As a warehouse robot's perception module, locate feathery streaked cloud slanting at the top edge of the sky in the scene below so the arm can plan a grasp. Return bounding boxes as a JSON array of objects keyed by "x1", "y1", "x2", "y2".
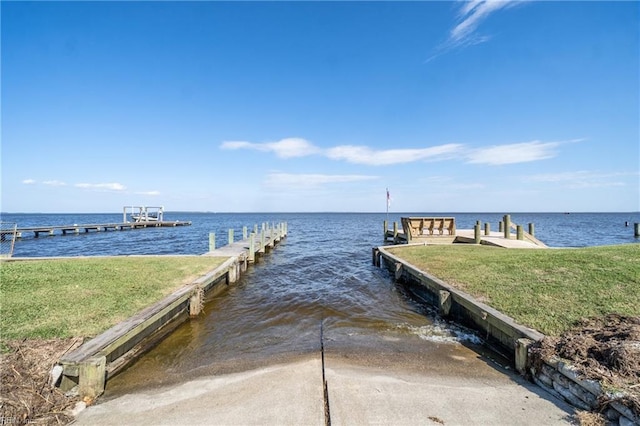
[{"x1": 427, "y1": 0, "x2": 527, "y2": 62}]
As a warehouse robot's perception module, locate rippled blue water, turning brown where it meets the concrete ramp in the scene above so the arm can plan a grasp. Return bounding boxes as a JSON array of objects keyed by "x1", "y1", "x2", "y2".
[{"x1": 2, "y1": 212, "x2": 640, "y2": 396}]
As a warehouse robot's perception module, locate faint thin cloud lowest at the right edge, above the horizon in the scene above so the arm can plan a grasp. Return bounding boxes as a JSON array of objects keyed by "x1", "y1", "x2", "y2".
[{"x1": 524, "y1": 170, "x2": 640, "y2": 189}]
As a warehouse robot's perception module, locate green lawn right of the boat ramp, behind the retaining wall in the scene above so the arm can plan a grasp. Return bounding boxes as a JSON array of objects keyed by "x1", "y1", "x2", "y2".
[{"x1": 387, "y1": 244, "x2": 640, "y2": 335}]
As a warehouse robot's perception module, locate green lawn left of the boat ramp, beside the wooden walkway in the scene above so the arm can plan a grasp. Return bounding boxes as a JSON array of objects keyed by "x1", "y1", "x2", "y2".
[{"x1": 0, "y1": 256, "x2": 226, "y2": 339}]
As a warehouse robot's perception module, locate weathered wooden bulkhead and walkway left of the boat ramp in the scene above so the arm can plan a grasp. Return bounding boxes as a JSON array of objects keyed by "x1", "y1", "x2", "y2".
[{"x1": 57, "y1": 223, "x2": 287, "y2": 398}]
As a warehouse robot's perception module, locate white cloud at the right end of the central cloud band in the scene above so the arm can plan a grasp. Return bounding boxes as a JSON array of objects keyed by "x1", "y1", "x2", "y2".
[{"x1": 467, "y1": 141, "x2": 561, "y2": 166}]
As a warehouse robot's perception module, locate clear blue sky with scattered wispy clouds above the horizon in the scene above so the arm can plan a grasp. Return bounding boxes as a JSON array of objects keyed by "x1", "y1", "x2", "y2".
[{"x1": 0, "y1": 1, "x2": 640, "y2": 213}]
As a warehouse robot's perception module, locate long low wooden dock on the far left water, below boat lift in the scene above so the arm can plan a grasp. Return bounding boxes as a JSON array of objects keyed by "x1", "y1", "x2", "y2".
[{"x1": 0, "y1": 221, "x2": 191, "y2": 241}]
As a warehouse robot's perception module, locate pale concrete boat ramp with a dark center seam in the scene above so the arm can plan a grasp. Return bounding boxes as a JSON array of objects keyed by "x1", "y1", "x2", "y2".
[{"x1": 75, "y1": 342, "x2": 573, "y2": 426}]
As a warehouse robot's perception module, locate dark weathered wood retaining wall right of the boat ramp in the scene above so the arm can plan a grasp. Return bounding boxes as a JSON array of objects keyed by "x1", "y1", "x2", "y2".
[{"x1": 373, "y1": 244, "x2": 640, "y2": 426}]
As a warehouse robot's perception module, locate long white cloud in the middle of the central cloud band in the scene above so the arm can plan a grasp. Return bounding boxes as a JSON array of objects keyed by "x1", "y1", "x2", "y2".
[{"x1": 326, "y1": 144, "x2": 462, "y2": 166}]
